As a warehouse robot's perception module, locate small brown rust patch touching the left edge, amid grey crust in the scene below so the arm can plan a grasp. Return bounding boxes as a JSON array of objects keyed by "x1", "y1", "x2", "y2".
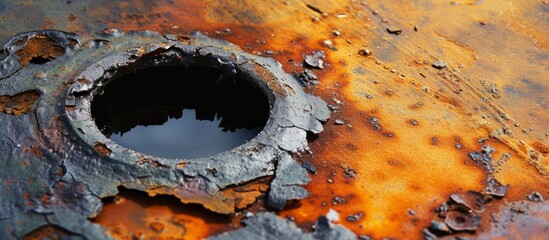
[{"x1": 0, "y1": 90, "x2": 40, "y2": 116}]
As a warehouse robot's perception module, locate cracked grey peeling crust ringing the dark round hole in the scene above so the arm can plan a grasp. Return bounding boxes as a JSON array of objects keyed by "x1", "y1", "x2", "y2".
[{"x1": 0, "y1": 29, "x2": 329, "y2": 238}]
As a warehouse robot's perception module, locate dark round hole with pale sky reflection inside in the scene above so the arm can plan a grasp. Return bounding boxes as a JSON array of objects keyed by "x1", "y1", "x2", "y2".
[{"x1": 91, "y1": 66, "x2": 270, "y2": 158}]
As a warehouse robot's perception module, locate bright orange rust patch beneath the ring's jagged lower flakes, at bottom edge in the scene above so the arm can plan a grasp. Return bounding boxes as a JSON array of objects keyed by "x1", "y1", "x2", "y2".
[{"x1": 92, "y1": 190, "x2": 235, "y2": 239}]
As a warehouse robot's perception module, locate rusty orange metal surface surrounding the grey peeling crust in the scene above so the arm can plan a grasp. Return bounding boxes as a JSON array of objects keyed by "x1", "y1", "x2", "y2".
[{"x1": 0, "y1": 0, "x2": 549, "y2": 239}]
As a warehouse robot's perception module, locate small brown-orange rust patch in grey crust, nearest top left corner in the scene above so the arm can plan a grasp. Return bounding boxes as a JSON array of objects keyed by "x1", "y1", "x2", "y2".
[{"x1": 15, "y1": 36, "x2": 65, "y2": 65}]
